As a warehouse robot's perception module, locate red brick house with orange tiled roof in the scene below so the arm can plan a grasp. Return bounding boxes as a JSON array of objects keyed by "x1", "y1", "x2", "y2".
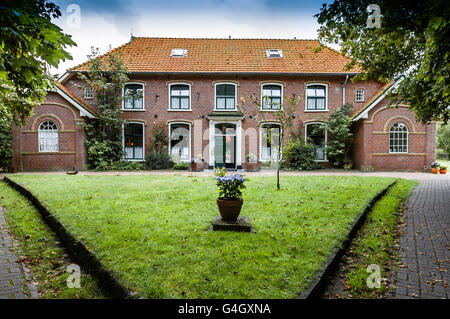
[{"x1": 9, "y1": 37, "x2": 435, "y2": 171}]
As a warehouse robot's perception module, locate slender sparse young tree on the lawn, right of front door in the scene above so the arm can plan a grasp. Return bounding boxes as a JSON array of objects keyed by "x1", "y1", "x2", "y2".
[{"x1": 238, "y1": 95, "x2": 301, "y2": 190}]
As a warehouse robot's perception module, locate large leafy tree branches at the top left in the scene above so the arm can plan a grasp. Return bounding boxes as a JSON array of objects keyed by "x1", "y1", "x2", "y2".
[{"x1": 0, "y1": 0, "x2": 76, "y2": 124}]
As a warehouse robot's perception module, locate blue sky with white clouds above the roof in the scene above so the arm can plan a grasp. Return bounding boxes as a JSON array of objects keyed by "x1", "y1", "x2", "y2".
[{"x1": 52, "y1": 0, "x2": 329, "y2": 75}]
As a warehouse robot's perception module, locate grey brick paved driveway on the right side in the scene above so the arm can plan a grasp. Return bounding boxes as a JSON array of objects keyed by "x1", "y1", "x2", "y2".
[{"x1": 395, "y1": 178, "x2": 450, "y2": 299}]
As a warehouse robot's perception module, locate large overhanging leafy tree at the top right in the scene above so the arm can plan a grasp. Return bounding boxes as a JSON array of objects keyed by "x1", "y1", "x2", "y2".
[{"x1": 316, "y1": 0, "x2": 450, "y2": 122}]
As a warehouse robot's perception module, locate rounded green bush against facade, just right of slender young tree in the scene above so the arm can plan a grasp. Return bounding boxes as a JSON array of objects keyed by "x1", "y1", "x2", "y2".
[{"x1": 281, "y1": 137, "x2": 321, "y2": 171}]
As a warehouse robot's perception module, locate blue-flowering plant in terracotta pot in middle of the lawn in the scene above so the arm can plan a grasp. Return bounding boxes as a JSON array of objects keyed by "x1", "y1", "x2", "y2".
[{"x1": 215, "y1": 168, "x2": 245, "y2": 222}]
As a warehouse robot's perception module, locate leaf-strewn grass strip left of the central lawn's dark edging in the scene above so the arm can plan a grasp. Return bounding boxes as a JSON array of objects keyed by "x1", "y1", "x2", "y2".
[{"x1": 0, "y1": 181, "x2": 102, "y2": 298}]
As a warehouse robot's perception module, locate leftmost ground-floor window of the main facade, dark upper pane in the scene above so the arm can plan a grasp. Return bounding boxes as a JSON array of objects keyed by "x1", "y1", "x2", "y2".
[{"x1": 123, "y1": 122, "x2": 145, "y2": 161}]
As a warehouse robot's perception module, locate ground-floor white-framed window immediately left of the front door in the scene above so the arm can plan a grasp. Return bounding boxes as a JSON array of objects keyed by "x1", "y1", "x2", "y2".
[{"x1": 169, "y1": 122, "x2": 191, "y2": 163}]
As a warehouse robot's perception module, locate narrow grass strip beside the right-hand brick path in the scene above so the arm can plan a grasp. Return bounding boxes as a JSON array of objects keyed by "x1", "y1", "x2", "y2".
[{"x1": 336, "y1": 179, "x2": 418, "y2": 298}]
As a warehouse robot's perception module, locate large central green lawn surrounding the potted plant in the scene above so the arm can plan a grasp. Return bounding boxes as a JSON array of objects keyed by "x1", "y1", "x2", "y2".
[{"x1": 6, "y1": 175, "x2": 393, "y2": 298}]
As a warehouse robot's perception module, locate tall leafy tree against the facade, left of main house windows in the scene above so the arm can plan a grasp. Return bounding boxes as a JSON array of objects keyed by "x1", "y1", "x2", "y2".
[{"x1": 78, "y1": 48, "x2": 130, "y2": 169}]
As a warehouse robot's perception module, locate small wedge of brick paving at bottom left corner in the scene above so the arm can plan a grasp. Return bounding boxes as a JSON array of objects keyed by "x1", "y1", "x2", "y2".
[{"x1": 0, "y1": 206, "x2": 36, "y2": 299}]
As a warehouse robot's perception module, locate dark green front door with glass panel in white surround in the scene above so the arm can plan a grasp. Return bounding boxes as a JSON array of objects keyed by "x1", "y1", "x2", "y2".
[{"x1": 214, "y1": 123, "x2": 236, "y2": 169}]
